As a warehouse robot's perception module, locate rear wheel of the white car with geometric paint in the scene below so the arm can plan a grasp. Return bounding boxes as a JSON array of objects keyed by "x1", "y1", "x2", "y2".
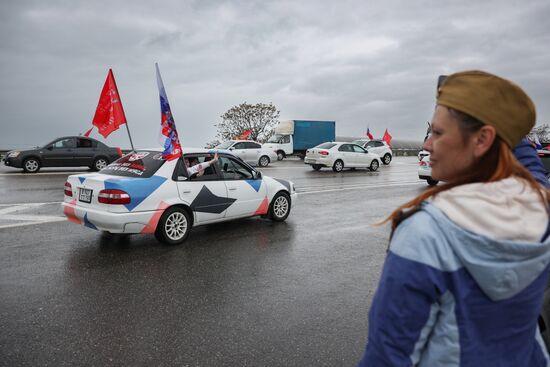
[{"x1": 155, "y1": 207, "x2": 191, "y2": 245}]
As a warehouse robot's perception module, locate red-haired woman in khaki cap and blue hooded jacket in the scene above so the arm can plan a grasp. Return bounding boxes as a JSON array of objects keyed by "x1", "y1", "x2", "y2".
[{"x1": 360, "y1": 71, "x2": 550, "y2": 367}]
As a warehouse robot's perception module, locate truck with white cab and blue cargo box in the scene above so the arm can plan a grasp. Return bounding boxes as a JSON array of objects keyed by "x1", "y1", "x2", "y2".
[{"x1": 262, "y1": 120, "x2": 336, "y2": 160}]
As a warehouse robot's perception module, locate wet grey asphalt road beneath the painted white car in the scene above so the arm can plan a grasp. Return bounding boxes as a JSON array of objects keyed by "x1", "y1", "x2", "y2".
[{"x1": 0, "y1": 157, "x2": 426, "y2": 366}]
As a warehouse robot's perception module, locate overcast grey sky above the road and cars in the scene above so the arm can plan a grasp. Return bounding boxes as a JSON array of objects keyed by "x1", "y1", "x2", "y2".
[{"x1": 0, "y1": 0, "x2": 550, "y2": 149}]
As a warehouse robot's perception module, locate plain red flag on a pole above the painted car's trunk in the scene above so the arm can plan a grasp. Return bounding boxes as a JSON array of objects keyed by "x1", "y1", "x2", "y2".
[{"x1": 92, "y1": 69, "x2": 126, "y2": 138}]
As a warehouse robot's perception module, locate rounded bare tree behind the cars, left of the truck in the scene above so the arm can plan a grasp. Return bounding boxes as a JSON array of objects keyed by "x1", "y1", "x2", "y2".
[{"x1": 214, "y1": 102, "x2": 280, "y2": 141}]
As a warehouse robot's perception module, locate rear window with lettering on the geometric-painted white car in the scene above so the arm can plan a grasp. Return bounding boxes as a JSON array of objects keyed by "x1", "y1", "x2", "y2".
[{"x1": 99, "y1": 151, "x2": 166, "y2": 178}]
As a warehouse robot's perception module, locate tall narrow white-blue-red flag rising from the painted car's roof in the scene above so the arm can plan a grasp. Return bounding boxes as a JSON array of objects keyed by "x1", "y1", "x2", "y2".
[{"x1": 155, "y1": 63, "x2": 181, "y2": 161}]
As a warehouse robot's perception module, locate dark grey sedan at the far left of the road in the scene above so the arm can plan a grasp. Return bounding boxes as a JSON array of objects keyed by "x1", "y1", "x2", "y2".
[{"x1": 4, "y1": 136, "x2": 122, "y2": 173}]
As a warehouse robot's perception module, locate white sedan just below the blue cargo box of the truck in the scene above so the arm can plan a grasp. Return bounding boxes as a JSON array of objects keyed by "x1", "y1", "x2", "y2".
[{"x1": 304, "y1": 142, "x2": 381, "y2": 172}]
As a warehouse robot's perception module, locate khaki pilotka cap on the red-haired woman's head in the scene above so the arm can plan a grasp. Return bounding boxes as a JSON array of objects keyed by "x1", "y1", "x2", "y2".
[{"x1": 437, "y1": 70, "x2": 536, "y2": 148}]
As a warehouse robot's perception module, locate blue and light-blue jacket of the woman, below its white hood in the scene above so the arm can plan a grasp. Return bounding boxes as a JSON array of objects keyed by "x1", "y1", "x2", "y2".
[{"x1": 359, "y1": 203, "x2": 550, "y2": 367}]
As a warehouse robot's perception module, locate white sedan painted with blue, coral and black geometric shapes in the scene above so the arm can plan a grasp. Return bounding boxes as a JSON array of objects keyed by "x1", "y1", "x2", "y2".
[{"x1": 62, "y1": 149, "x2": 297, "y2": 244}]
